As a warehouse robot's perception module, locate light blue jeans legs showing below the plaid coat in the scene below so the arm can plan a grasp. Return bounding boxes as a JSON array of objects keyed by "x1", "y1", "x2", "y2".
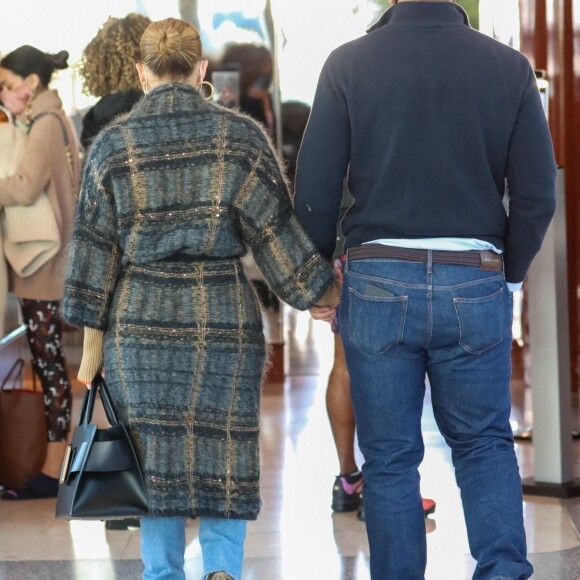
[{"x1": 141, "y1": 516, "x2": 247, "y2": 580}]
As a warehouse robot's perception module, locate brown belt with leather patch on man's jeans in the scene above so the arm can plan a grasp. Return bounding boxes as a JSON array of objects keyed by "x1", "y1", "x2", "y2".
[{"x1": 347, "y1": 244, "x2": 503, "y2": 272}]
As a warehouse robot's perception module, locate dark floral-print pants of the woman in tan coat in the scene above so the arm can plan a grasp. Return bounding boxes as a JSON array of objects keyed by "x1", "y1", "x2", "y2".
[{"x1": 20, "y1": 299, "x2": 72, "y2": 442}]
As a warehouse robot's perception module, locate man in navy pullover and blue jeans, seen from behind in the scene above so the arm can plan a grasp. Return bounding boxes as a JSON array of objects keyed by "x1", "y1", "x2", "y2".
[{"x1": 295, "y1": 0, "x2": 556, "y2": 580}]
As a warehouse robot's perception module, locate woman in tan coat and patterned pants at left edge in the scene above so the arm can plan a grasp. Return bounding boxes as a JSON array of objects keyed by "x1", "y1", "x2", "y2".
[{"x1": 0, "y1": 45, "x2": 80, "y2": 500}]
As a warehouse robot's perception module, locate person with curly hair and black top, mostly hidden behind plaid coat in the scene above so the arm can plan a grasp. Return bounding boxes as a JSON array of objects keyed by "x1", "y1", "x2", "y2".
[{"x1": 79, "y1": 12, "x2": 151, "y2": 149}]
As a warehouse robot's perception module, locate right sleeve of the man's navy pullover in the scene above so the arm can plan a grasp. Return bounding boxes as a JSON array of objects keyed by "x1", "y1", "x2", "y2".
[{"x1": 505, "y1": 67, "x2": 556, "y2": 282}]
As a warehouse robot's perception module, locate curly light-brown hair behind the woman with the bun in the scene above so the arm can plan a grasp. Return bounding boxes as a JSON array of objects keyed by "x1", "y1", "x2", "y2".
[{"x1": 79, "y1": 12, "x2": 151, "y2": 97}]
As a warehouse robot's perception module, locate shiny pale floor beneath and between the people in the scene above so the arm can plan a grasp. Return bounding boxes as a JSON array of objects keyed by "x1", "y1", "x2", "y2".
[{"x1": 0, "y1": 312, "x2": 580, "y2": 580}]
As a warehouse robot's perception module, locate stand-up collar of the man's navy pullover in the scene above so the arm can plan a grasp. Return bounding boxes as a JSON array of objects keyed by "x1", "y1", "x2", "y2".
[{"x1": 367, "y1": 2, "x2": 469, "y2": 32}]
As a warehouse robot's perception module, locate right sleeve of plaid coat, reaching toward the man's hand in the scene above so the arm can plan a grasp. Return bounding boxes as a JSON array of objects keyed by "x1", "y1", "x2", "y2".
[{"x1": 236, "y1": 133, "x2": 338, "y2": 310}]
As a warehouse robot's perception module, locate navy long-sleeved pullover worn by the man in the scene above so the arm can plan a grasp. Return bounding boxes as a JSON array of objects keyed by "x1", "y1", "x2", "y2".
[{"x1": 295, "y1": 2, "x2": 556, "y2": 282}]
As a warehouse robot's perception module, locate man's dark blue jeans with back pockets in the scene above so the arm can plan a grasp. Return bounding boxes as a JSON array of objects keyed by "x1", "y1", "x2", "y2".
[{"x1": 340, "y1": 259, "x2": 533, "y2": 580}]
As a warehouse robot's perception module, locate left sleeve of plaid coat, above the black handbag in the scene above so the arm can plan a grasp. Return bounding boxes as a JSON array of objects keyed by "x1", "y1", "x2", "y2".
[{"x1": 62, "y1": 146, "x2": 121, "y2": 330}]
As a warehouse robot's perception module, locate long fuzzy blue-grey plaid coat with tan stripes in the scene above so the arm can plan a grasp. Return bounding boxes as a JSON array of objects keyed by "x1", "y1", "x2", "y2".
[{"x1": 63, "y1": 84, "x2": 333, "y2": 519}]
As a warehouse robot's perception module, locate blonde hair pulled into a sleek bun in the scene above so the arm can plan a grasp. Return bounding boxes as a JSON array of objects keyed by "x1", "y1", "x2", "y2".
[{"x1": 141, "y1": 18, "x2": 202, "y2": 79}]
